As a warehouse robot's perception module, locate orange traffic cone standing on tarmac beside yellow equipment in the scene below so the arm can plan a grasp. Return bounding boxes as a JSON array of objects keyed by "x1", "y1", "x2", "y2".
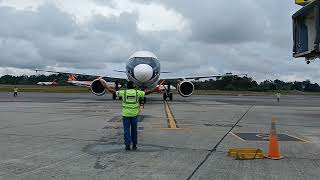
[{"x1": 268, "y1": 118, "x2": 283, "y2": 160}]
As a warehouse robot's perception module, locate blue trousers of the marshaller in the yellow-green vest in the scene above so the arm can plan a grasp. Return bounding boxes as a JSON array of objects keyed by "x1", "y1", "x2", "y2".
[{"x1": 123, "y1": 116, "x2": 138, "y2": 145}]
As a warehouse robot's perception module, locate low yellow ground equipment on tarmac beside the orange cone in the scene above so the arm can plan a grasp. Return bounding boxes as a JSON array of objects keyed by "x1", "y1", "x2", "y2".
[{"x1": 228, "y1": 148, "x2": 264, "y2": 160}]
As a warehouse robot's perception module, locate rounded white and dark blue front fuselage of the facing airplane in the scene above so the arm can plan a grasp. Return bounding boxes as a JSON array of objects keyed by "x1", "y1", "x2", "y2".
[{"x1": 126, "y1": 51, "x2": 160, "y2": 89}]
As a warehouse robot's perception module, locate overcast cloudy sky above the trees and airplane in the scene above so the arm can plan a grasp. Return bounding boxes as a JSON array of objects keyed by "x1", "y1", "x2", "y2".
[{"x1": 0, "y1": 0, "x2": 320, "y2": 82}]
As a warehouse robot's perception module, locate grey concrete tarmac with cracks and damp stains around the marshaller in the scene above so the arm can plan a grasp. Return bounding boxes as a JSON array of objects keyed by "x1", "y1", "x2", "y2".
[{"x1": 0, "y1": 93, "x2": 320, "y2": 180}]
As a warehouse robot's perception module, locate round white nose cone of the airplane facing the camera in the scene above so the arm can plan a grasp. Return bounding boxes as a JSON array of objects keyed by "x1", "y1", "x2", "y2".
[{"x1": 133, "y1": 64, "x2": 153, "y2": 82}]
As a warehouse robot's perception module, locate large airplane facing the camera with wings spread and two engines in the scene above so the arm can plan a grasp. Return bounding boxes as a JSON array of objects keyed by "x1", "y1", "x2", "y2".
[{"x1": 36, "y1": 51, "x2": 242, "y2": 100}]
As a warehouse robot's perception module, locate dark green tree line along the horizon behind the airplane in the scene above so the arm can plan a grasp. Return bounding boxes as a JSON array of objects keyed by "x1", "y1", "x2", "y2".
[{"x1": 0, "y1": 74, "x2": 320, "y2": 92}]
